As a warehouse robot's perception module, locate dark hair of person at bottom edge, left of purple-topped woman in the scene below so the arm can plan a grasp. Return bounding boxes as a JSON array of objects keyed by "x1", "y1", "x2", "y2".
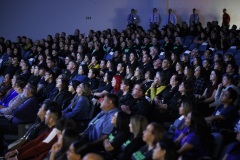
[{"x1": 158, "y1": 139, "x2": 178, "y2": 160}]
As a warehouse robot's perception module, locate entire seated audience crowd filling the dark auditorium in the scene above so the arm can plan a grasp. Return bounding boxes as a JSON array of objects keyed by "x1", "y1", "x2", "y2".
[{"x1": 0, "y1": 10, "x2": 240, "y2": 160}]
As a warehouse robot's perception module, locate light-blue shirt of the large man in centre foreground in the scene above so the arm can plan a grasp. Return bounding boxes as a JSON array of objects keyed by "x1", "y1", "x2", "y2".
[{"x1": 83, "y1": 108, "x2": 119, "y2": 142}]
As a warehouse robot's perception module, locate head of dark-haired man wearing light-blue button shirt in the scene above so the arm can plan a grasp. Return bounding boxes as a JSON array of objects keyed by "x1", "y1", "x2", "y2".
[{"x1": 100, "y1": 94, "x2": 118, "y2": 112}]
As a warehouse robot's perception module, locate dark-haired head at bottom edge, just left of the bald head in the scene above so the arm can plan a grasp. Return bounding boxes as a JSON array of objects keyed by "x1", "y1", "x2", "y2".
[{"x1": 67, "y1": 141, "x2": 90, "y2": 160}]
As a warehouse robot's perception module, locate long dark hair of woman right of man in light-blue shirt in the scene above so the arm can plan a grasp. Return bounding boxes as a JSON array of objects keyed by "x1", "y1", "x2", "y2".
[{"x1": 116, "y1": 111, "x2": 130, "y2": 131}]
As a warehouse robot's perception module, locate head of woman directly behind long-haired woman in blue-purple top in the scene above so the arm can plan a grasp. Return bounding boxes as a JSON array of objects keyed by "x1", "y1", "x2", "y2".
[{"x1": 179, "y1": 98, "x2": 194, "y2": 117}]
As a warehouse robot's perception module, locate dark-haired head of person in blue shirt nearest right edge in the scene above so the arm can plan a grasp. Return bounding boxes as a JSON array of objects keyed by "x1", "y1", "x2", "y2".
[{"x1": 221, "y1": 87, "x2": 237, "y2": 104}]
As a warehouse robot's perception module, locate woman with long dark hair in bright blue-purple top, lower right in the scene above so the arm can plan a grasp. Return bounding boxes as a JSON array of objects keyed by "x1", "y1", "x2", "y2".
[{"x1": 178, "y1": 111, "x2": 212, "y2": 159}]
